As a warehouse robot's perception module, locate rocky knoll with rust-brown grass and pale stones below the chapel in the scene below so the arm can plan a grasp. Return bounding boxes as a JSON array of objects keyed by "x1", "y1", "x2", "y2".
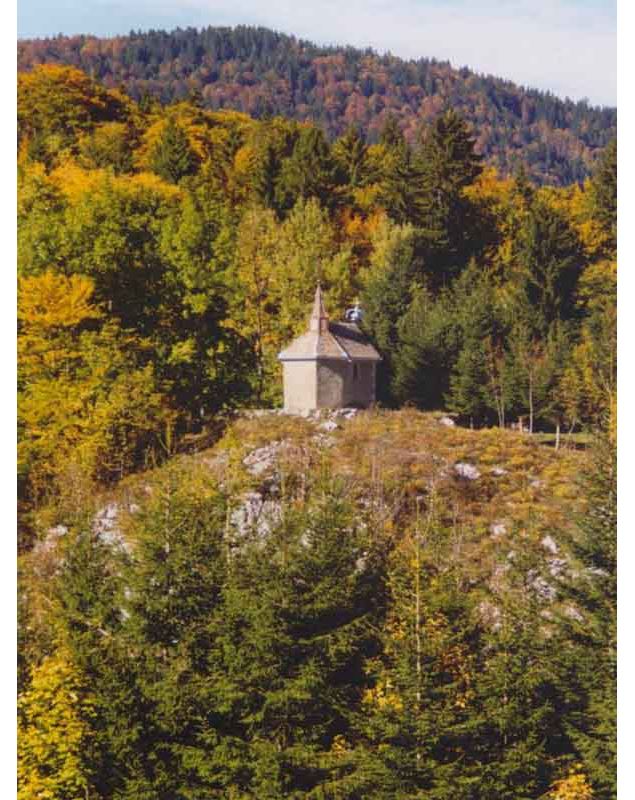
[{"x1": 29, "y1": 409, "x2": 587, "y2": 584}]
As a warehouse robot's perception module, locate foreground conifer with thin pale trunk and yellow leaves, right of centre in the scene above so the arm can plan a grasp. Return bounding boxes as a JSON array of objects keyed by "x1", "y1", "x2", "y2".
[{"x1": 343, "y1": 490, "x2": 481, "y2": 800}]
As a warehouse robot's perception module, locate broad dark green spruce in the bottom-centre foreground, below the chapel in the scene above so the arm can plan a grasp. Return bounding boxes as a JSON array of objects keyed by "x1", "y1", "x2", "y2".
[{"x1": 212, "y1": 484, "x2": 382, "y2": 800}]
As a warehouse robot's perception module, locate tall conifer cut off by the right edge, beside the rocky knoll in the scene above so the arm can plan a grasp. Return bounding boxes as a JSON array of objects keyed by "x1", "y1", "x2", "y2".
[{"x1": 556, "y1": 431, "x2": 617, "y2": 800}]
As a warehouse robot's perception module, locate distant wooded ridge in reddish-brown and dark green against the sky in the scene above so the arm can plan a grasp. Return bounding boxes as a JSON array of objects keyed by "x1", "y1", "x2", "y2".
[{"x1": 18, "y1": 26, "x2": 617, "y2": 185}]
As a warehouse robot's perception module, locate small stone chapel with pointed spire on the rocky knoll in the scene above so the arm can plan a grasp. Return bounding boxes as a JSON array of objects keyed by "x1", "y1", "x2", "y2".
[{"x1": 278, "y1": 284, "x2": 381, "y2": 413}]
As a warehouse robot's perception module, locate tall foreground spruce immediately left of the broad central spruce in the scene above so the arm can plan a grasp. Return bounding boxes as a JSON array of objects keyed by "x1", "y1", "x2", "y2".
[{"x1": 120, "y1": 465, "x2": 227, "y2": 800}]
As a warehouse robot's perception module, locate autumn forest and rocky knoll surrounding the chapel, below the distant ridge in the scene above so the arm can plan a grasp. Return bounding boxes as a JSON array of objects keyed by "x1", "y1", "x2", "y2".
[{"x1": 18, "y1": 64, "x2": 617, "y2": 800}]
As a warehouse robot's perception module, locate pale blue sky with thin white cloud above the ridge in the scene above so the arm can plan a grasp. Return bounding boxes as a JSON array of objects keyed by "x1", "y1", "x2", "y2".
[{"x1": 18, "y1": 0, "x2": 617, "y2": 106}]
